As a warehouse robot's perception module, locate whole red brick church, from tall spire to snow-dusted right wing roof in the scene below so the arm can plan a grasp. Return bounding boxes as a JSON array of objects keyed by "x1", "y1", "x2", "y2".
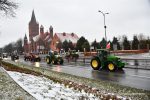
[{"x1": 24, "y1": 10, "x2": 79, "y2": 53}]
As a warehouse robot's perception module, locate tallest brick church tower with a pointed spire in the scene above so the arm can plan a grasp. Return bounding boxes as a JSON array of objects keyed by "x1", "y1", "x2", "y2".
[{"x1": 29, "y1": 10, "x2": 39, "y2": 41}]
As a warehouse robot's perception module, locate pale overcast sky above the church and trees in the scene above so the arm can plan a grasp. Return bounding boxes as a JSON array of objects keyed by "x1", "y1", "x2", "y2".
[{"x1": 0, "y1": 0, "x2": 150, "y2": 47}]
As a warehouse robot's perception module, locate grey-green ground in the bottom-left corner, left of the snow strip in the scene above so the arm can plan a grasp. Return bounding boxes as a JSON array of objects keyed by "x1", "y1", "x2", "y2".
[{"x1": 0, "y1": 66, "x2": 36, "y2": 100}]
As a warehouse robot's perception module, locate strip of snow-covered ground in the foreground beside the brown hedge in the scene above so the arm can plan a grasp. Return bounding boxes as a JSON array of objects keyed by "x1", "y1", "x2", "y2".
[{"x1": 7, "y1": 71, "x2": 99, "y2": 100}]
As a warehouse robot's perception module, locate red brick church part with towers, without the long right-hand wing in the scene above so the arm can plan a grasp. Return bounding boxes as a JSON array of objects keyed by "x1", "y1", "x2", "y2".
[{"x1": 24, "y1": 10, "x2": 53, "y2": 52}]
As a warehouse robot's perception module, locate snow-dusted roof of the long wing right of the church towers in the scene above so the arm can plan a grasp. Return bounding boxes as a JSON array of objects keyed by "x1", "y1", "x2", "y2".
[{"x1": 56, "y1": 33, "x2": 79, "y2": 43}]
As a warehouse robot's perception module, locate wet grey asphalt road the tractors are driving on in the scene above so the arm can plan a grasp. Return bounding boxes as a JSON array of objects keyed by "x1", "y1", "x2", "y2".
[{"x1": 14, "y1": 59, "x2": 150, "y2": 90}]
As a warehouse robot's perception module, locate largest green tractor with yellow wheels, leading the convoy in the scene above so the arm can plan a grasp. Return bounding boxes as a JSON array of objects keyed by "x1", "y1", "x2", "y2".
[{"x1": 91, "y1": 49, "x2": 125, "y2": 71}]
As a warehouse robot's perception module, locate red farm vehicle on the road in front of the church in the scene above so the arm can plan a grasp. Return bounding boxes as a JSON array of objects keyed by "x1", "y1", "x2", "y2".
[{"x1": 24, "y1": 53, "x2": 41, "y2": 62}]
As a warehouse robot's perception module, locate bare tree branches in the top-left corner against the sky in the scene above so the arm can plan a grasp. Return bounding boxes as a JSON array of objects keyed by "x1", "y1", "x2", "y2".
[{"x1": 0, "y1": 0, "x2": 18, "y2": 17}]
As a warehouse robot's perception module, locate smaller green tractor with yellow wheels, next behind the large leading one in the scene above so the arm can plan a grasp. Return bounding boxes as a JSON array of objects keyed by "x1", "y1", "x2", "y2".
[{"x1": 46, "y1": 51, "x2": 64, "y2": 65}]
